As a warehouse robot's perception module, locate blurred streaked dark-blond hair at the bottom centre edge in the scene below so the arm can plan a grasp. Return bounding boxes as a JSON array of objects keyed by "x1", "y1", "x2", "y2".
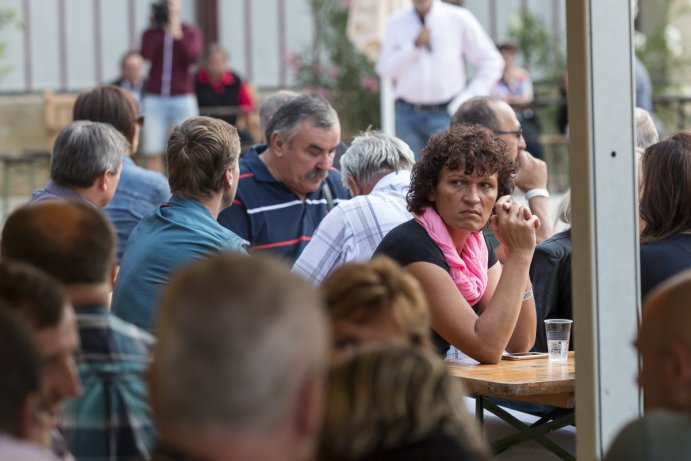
[{"x1": 318, "y1": 344, "x2": 489, "y2": 461}]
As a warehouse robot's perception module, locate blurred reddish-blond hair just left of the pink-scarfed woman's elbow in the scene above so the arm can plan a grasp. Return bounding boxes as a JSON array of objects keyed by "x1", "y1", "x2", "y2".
[{"x1": 322, "y1": 256, "x2": 433, "y2": 351}]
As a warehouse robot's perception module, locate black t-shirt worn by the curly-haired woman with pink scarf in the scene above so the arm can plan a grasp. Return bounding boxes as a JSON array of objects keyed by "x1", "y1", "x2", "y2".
[{"x1": 374, "y1": 219, "x2": 497, "y2": 356}]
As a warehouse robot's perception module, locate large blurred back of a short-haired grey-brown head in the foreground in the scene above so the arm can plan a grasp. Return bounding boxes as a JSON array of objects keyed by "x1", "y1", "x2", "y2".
[{"x1": 151, "y1": 253, "x2": 329, "y2": 442}]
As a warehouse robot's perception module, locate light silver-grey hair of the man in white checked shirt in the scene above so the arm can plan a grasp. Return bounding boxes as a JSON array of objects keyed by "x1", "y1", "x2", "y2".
[{"x1": 341, "y1": 131, "x2": 415, "y2": 192}]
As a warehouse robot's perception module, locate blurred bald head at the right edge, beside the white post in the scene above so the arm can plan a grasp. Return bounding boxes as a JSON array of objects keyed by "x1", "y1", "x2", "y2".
[{"x1": 636, "y1": 271, "x2": 691, "y2": 411}]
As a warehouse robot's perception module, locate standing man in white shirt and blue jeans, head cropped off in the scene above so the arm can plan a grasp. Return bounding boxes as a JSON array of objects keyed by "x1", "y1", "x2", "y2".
[{"x1": 377, "y1": 0, "x2": 504, "y2": 158}]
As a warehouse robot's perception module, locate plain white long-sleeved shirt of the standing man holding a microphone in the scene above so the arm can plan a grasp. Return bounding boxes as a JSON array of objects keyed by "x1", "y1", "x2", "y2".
[{"x1": 377, "y1": 0, "x2": 504, "y2": 114}]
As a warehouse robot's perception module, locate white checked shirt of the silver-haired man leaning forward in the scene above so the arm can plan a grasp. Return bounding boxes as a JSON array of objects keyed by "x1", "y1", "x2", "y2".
[{"x1": 293, "y1": 170, "x2": 412, "y2": 285}]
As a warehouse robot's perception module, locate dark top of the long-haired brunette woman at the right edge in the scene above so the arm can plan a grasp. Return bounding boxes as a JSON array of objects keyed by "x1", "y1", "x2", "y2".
[{"x1": 641, "y1": 234, "x2": 691, "y2": 298}]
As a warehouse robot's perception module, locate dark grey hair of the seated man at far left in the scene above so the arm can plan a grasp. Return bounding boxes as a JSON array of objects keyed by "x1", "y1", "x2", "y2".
[{"x1": 50, "y1": 120, "x2": 130, "y2": 187}]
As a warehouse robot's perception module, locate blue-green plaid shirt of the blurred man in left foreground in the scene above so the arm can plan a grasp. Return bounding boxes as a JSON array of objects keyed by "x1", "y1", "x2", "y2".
[{"x1": 61, "y1": 306, "x2": 155, "y2": 461}]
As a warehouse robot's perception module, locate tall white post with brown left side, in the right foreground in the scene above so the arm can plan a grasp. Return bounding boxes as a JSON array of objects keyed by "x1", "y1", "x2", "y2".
[{"x1": 566, "y1": 0, "x2": 640, "y2": 461}]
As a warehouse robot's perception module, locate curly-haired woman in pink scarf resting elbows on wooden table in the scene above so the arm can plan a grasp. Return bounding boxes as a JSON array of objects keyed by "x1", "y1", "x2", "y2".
[{"x1": 377, "y1": 125, "x2": 540, "y2": 363}]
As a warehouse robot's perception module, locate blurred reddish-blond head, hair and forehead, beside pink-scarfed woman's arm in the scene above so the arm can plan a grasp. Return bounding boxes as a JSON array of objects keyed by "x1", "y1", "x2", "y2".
[{"x1": 321, "y1": 256, "x2": 433, "y2": 357}]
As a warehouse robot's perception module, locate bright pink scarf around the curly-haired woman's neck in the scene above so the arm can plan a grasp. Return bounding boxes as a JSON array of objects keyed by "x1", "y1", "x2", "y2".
[{"x1": 415, "y1": 207, "x2": 488, "y2": 306}]
